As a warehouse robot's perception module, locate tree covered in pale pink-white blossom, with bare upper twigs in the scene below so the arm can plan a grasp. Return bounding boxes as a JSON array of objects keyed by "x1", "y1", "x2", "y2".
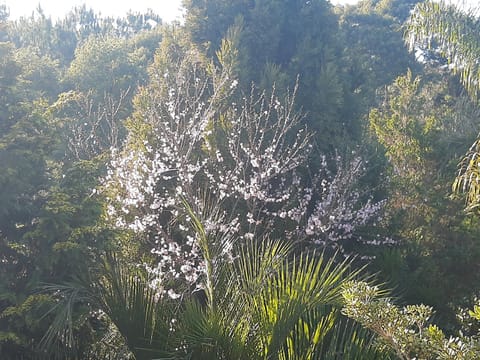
[{"x1": 104, "y1": 29, "x2": 382, "y2": 297}]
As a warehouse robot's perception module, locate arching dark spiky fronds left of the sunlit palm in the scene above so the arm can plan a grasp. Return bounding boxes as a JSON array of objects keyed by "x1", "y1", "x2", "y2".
[{"x1": 42, "y1": 255, "x2": 173, "y2": 360}]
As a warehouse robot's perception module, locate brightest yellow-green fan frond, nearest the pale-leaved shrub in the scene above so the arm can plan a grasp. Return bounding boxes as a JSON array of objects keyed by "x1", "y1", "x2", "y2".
[{"x1": 261, "y1": 253, "x2": 357, "y2": 356}]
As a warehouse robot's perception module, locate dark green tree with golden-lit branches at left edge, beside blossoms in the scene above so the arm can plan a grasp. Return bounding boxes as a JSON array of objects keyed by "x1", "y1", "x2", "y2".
[{"x1": 0, "y1": 99, "x2": 120, "y2": 359}]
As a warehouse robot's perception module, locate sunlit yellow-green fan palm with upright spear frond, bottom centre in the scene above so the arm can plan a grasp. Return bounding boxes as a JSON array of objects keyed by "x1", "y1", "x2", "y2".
[{"x1": 179, "y1": 208, "x2": 384, "y2": 359}]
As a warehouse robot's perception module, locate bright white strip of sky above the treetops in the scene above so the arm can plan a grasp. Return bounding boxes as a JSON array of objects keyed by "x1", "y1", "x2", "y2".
[{"x1": 0, "y1": 0, "x2": 478, "y2": 21}]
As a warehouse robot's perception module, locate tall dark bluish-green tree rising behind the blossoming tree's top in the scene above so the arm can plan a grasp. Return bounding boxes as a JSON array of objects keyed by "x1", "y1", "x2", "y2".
[{"x1": 185, "y1": 0, "x2": 359, "y2": 149}]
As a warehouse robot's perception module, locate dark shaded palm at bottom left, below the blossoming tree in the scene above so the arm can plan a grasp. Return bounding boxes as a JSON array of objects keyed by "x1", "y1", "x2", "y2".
[{"x1": 40, "y1": 254, "x2": 176, "y2": 360}]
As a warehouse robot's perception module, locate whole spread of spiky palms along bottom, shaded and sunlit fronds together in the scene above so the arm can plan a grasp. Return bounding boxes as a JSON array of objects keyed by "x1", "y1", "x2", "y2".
[{"x1": 45, "y1": 204, "x2": 387, "y2": 360}]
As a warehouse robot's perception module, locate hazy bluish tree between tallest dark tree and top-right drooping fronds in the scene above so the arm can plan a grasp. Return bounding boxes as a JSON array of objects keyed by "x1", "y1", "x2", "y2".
[{"x1": 339, "y1": 1, "x2": 418, "y2": 109}]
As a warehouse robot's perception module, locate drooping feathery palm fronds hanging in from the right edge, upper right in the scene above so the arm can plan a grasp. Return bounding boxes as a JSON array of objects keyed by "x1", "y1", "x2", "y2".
[{"x1": 406, "y1": 1, "x2": 480, "y2": 210}]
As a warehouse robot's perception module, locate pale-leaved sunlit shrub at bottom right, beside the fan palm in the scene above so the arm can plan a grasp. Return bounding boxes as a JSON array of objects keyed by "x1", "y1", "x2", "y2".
[{"x1": 342, "y1": 282, "x2": 480, "y2": 360}]
